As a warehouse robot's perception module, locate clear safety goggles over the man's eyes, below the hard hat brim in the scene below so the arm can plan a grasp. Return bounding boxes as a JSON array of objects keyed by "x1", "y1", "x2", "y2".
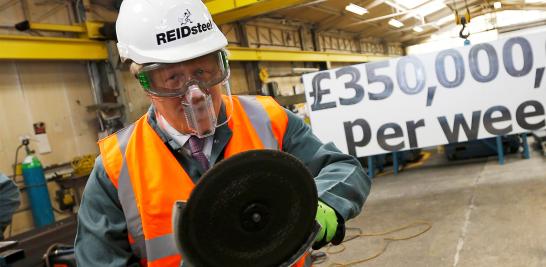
[{"x1": 136, "y1": 50, "x2": 229, "y2": 97}]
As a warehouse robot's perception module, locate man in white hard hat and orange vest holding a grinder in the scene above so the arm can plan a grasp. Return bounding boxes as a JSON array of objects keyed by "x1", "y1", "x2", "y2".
[{"x1": 76, "y1": 0, "x2": 371, "y2": 266}]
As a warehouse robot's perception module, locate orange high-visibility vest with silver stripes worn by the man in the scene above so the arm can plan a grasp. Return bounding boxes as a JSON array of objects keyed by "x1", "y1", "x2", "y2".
[{"x1": 99, "y1": 96, "x2": 310, "y2": 267}]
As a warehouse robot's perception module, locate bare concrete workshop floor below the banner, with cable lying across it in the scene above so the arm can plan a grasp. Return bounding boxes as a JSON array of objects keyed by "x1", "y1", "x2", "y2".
[{"x1": 317, "y1": 153, "x2": 546, "y2": 267}]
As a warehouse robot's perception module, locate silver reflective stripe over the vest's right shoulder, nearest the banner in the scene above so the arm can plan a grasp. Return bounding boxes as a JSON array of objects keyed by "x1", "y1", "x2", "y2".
[{"x1": 238, "y1": 96, "x2": 280, "y2": 149}]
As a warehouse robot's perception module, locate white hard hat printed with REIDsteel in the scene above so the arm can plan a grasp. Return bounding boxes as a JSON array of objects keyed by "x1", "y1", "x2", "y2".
[{"x1": 116, "y1": 0, "x2": 228, "y2": 64}]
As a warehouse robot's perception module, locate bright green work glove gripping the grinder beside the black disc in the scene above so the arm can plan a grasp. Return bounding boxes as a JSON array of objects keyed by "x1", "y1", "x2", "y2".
[{"x1": 313, "y1": 200, "x2": 338, "y2": 249}]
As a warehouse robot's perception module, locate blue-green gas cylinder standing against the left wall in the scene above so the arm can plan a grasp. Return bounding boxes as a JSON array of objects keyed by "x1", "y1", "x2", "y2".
[{"x1": 22, "y1": 154, "x2": 55, "y2": 228}]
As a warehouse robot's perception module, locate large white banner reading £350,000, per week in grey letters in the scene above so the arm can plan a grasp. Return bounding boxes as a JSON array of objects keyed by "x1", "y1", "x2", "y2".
[{"x1": 303, "y1": 33, "x2": 546, "y2": 157}]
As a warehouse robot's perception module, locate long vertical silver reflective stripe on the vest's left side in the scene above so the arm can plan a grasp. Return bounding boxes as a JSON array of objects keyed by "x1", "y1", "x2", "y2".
[{"x1": 116, "y1": 124, "x2": 146, "y2": 259}]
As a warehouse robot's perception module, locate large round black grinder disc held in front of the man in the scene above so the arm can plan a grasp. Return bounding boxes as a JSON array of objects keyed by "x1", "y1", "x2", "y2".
[{"x1": 174, "y1": 150, "x2": 317, "y2": 267}]
